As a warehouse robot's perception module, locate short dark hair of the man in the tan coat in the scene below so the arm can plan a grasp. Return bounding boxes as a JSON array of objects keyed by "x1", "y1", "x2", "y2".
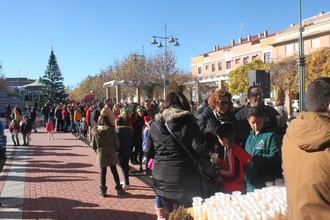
[{"x1": 305, "y1": 77, "x2": 330, "y2": 112}]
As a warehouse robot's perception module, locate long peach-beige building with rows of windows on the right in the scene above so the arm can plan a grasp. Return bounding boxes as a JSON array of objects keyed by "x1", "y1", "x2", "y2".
[{"x1": 191, "y1": 12, "x2": 330, "y2": 101}]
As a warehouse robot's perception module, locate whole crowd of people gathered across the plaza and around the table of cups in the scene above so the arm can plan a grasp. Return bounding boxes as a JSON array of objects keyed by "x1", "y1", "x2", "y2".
[{"x1": 3, "y1": 78, "x2": 330, "y2": 220}]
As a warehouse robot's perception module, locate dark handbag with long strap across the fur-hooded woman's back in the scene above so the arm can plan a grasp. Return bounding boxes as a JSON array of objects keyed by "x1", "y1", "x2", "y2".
[{"x1": 165, "y1": 123, "x2": 220, "y2": 198}]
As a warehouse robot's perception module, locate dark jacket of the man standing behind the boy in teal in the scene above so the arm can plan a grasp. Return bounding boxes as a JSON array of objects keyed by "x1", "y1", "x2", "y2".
[{"x1": 235, "y1": 103, "x2": 279, "y2": 146}]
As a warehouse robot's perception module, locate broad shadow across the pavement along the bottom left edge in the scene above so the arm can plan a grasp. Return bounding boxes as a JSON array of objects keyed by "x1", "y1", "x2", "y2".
[{"x1": 0, "y1": 197, "x2": 155, "y2": 220}]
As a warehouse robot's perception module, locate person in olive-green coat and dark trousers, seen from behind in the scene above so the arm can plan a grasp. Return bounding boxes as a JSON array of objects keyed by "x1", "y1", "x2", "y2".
[{"x1": 91, "y1": 115, "x2": 125, "y2": 197}]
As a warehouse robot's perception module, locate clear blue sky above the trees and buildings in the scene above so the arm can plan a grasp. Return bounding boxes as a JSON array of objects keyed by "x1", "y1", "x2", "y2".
[{"x1": 0, "y1": 0, "x2": 330, "y2": 86}]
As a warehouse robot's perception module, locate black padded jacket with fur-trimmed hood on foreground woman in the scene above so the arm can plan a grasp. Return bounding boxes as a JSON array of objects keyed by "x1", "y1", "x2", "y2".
[{"x1": 147, "y1": 108, "x2": 206, "y2": 204}]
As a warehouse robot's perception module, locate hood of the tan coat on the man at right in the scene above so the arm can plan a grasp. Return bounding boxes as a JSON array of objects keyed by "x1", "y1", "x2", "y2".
[{"x1": 285, "y1": 112, "x2": 330, "y2": 152}]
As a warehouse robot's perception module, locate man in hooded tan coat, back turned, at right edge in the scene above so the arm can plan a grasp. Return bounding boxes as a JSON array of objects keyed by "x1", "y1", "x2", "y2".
[{"x1": 282, "y1": 77, "x2": 330, "y2": 220}]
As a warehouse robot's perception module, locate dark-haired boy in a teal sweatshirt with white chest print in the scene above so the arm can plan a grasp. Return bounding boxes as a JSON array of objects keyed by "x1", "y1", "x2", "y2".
[{"x1": 245, "y1": 107, "x2": 282, "y2": 192}]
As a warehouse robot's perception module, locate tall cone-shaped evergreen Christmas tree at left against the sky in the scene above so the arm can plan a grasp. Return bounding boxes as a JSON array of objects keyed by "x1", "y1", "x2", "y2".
[{"x1": 42, "y1": 49, "x2": 68, "y2": 104}]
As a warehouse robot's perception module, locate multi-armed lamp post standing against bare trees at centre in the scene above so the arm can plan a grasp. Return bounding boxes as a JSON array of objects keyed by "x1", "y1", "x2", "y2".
[{"x1": 151, "y1": 24, "x2": 180, "y2": 99}]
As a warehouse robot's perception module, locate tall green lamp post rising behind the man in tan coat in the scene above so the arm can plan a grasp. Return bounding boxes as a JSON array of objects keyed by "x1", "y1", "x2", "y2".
[{"x1": 298, "y1": 0, "x2": 305, "y2": 111}]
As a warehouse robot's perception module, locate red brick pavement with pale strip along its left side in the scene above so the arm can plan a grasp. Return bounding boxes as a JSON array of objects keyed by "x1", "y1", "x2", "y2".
[{"x1": 0, "y1": 128, "x2": 156, "y2": 220}]
